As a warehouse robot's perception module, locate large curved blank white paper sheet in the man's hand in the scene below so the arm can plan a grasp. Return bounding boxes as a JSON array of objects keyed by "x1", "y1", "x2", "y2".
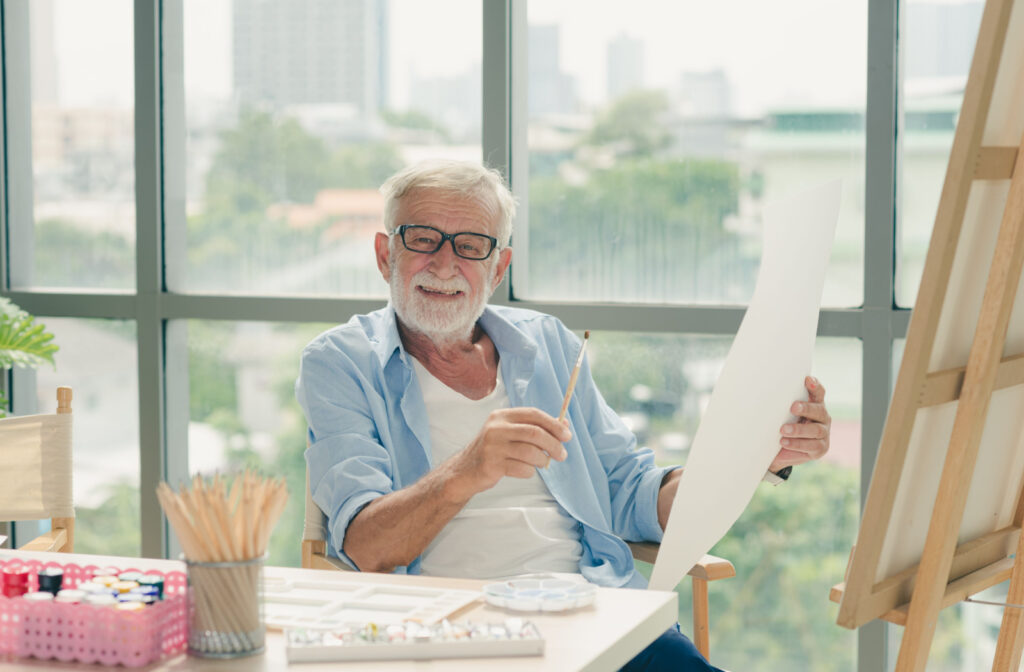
[{"x1": 650, "y1": 180, "x2": 841, "y2": 590}]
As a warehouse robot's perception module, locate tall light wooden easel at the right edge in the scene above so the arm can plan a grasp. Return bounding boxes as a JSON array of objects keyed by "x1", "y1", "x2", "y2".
[{"x1": 833, "y1": 0, "x2": 1024, "y2": 672}]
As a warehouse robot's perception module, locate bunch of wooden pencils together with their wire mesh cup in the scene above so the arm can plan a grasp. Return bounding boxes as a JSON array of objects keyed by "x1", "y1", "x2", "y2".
[{"x1": 157, "y1": 471, "x2": 288, "y2": 658}]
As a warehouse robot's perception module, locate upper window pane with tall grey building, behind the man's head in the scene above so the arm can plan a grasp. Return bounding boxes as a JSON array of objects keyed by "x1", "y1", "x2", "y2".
[{"x1": 179, "y1": 0, "x2": 482, "y2": 296}]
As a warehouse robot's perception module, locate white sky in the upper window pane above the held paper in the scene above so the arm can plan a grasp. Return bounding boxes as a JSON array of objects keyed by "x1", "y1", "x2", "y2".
[{"x1": 528, "y1": 0, "x2": 867, "y2": 114}]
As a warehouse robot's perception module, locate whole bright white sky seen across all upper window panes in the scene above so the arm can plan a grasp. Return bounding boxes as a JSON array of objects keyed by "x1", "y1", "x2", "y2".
[{"x1": 44, "y1": 0, "x2": 974, "y2": 115}]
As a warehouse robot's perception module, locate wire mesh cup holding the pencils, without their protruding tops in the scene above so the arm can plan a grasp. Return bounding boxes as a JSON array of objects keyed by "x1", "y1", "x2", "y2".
[{"x1": 185, "y1": 556, "x2": 266, "y2": 658}]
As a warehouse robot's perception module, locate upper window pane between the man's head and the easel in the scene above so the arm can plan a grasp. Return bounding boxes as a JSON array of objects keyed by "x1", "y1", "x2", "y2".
[{"x1": 514, "y1": 0, "x2": 867, "y2": 306}]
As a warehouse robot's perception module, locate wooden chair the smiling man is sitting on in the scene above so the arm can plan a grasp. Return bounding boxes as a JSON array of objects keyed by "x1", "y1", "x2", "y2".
[{"x1": 302, "y1": 467, "x2": 736, "y2": 658}]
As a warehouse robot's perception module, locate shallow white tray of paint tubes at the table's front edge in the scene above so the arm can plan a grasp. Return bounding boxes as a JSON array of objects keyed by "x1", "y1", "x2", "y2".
[{"x1": 285, "y1": 618, "x2": 544, "y2": 663}]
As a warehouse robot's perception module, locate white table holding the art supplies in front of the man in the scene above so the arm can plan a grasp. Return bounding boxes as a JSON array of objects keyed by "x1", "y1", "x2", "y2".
[{"x1": 0, "y1": 550, "x2": 678, "y2": 672}]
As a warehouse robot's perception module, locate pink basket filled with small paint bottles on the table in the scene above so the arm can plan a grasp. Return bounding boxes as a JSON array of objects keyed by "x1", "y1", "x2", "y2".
[{"x1": 0, "y1": 558, "x2": 188, "y2": 667}]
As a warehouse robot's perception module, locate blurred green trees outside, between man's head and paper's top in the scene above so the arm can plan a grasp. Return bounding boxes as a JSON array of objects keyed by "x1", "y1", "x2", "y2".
[{"x1": 529, "y1": 158, "x2": 756, "y2": 301}]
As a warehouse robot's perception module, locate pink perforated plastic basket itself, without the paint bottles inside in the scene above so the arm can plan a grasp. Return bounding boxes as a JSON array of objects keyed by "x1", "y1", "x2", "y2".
[{"x1": 0, "y1": 559, "x2": 188, "y2": 667}]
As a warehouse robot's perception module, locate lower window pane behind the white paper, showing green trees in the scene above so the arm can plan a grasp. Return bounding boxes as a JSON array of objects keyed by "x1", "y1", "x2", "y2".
[{"x1": 610, "y1": 332, "x2": 861, "y2": 671}]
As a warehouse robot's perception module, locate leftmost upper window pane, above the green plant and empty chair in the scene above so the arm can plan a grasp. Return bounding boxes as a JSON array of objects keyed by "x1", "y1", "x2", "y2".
[{"x1": 17, "y1": 0, "x2": 135, "y2": 289}]
